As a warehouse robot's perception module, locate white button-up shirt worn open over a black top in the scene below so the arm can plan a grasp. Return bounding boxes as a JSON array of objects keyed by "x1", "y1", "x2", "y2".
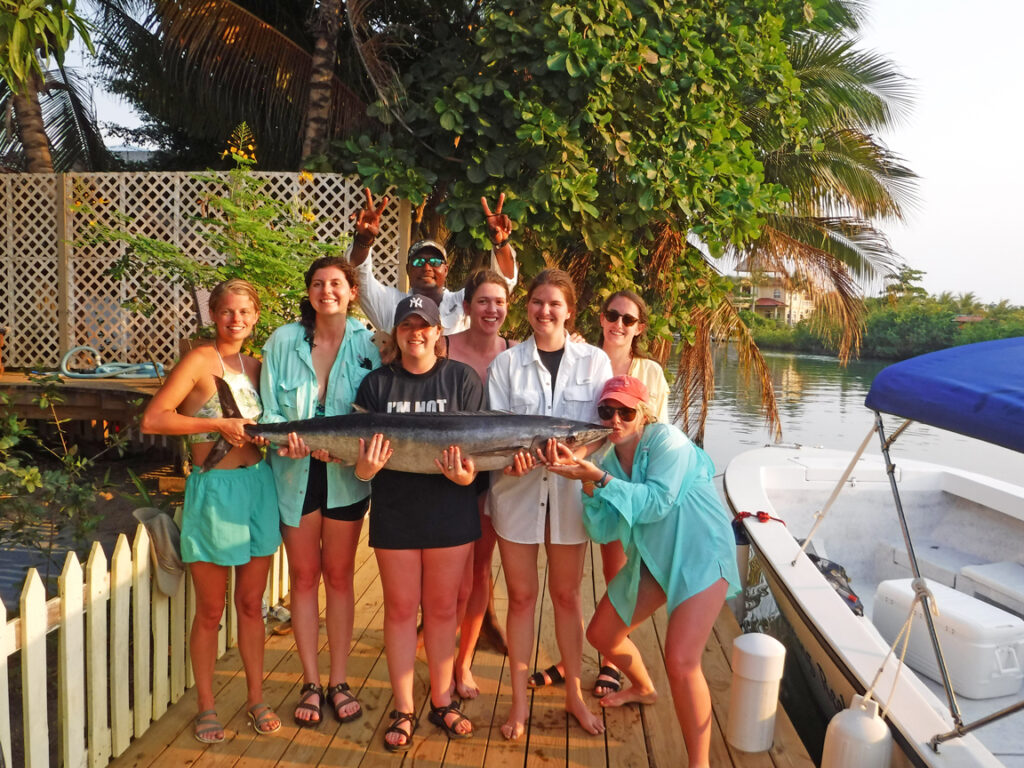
[{"x1": 487, "y1": 336, "x2": 611, "y2": 544}]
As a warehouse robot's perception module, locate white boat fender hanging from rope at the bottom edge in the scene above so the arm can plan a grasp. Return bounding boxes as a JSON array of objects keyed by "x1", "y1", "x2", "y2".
[{"x1": 821, "y1": 694, "x2": 893, "y2": 768}]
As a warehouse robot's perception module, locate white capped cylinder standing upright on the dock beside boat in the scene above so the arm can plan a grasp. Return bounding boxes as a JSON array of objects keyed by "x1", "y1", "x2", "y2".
[{"x1": 725, "y1": 632, "x2": 785, "y2": 752}]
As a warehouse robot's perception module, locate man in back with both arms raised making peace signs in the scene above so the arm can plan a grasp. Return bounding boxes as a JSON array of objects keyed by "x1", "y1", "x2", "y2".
[{"x1": 348, "y1": 189, "x2": 518, "y2": 335}]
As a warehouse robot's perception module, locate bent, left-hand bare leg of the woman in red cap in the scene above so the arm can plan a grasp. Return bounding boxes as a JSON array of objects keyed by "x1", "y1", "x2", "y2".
[{"x1": 587, "y1": 568, "x2": 665, "y2": 707}]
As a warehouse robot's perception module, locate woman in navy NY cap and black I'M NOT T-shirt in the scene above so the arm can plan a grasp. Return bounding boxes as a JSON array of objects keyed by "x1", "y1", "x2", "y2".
[{"x1": 355, "y1": 294, "x2": 483, "y2": 752}]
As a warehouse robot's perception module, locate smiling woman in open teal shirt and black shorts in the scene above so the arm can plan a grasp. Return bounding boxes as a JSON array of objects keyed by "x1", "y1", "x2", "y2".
[{"x1": 261, "y1": 257, "x2": 380, "y2": 727}]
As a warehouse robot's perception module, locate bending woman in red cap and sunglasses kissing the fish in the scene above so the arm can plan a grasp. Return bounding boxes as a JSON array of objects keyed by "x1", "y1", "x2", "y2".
[{"x1": 548, "y1": 376, "x2": 739, "y2": 768}]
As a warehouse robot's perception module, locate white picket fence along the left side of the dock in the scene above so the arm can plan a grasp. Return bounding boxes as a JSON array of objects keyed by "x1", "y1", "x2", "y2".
[{"x1": 0, "y1": 525, "x2": 289, "y2": 768}]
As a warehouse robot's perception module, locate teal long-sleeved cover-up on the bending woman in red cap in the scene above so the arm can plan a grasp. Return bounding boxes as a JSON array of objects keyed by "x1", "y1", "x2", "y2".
[{"x1": 584, "y1": 424, "x2": 740, "y2": 625}]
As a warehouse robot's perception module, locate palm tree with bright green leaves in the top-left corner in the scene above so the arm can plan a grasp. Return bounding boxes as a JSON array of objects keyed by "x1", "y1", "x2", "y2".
[{"x1": 0, "y1": 0, "x2": 92, "y2": 173}]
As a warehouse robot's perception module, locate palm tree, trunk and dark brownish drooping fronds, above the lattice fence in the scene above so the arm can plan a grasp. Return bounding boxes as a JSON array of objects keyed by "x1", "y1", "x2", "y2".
[{"x1": 96, "y1": 0, "x2": 372, "y2": 169}]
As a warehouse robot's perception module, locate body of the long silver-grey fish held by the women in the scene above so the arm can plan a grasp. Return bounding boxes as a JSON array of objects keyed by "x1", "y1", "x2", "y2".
[{"x1": 246, "y1": 411, "x2": 611, "y2": 474}]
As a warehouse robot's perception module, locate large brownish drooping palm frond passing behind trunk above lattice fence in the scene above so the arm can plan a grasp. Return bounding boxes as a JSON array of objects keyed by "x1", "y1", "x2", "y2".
[{"x1": 92, "y1": 0, "x2": 371, "y2": 166}]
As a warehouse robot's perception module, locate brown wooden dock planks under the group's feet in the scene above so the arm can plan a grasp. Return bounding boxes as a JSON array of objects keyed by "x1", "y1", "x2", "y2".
[{"x1": 103, "y1": 531, "x2": 813, "y2": 768}]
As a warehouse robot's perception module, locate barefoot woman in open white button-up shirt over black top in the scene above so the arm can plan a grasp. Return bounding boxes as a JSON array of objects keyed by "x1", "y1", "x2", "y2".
[{"x1": 487, "y1": 269, "x2": 611, "y2": 739}]
